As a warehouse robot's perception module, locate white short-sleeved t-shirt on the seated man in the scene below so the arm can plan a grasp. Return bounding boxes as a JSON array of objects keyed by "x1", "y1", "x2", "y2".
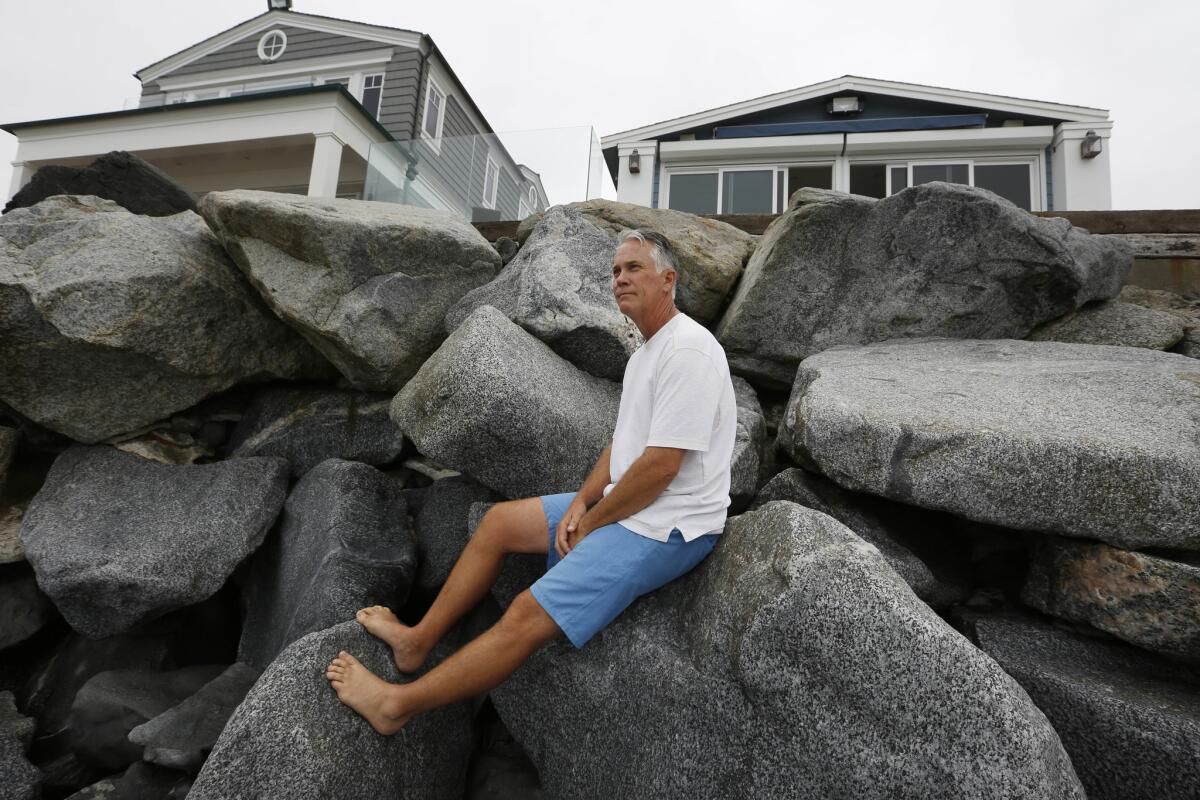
[{"x1": 604, "y1": 313, "x2": 738, "y2": 542}]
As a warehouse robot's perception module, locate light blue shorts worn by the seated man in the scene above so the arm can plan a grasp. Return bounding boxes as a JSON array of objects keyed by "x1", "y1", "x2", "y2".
[{"x1": 529, "y1": 492, "x2": 719, "y2": 648}]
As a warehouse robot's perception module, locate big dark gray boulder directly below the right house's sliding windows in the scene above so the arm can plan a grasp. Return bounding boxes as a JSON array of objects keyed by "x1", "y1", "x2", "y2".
[{"x1": 716, "y1": 188, "x2": 1133, "y2": 386}]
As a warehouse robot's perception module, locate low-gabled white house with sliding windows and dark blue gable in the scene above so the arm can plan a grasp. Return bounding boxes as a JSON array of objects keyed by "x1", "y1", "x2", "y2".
[{"x1": 601, "y1": 76, "x2": 1112, "y2": 213}]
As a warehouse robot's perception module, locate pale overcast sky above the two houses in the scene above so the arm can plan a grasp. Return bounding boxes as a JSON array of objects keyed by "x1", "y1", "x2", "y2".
[{"x1": 0, "y1": 0, "x2": 1200, "y2": 209}]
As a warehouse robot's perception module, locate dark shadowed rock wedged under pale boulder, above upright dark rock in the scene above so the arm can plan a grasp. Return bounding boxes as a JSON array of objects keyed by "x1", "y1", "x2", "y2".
[{"x1": 229, "y1": 389, "x2": 404, "y2": 477}]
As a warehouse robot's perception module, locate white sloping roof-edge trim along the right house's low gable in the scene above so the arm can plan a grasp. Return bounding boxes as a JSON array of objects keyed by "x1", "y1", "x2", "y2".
[{"x1": 600, "y1": 76, "x2": 1109, "y2": 149}]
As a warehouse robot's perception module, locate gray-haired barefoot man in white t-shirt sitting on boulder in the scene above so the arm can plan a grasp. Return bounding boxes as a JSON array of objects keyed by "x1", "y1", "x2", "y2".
[{"x1": 325, "y1": 230, "x2": 737, "y2": 734}]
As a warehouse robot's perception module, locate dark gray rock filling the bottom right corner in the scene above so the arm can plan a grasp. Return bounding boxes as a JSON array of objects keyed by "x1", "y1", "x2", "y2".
[{"x1": 974, "y1": 618, "x2": 1200, "y2": 800}]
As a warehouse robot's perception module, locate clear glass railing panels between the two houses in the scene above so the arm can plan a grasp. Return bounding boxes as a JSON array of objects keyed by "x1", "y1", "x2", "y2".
[{"x1": 362, "y1": 127, "x2": 617, "y2": 222}]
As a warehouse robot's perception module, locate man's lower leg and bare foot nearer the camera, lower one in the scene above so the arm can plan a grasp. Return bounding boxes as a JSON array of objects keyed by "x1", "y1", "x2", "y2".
[{"x1": 325, "y1": 592, "x2": 559, "y2": 735}]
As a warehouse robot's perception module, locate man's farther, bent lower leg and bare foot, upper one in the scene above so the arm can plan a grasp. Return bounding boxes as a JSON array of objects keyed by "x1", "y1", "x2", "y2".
[{"x1": 355, "y1": 498, "x2": 553, "y2": 673}]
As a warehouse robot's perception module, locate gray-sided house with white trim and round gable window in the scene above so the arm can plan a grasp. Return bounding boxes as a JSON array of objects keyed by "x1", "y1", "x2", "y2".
[{"x1": 0, "y1": 0, "x2": 547, "y2": 219}]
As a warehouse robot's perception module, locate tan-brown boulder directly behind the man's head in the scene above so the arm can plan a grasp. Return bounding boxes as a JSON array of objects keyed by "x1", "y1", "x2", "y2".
[{"x1": 517, "y1": 200, "x2": 756, "y2": 324}]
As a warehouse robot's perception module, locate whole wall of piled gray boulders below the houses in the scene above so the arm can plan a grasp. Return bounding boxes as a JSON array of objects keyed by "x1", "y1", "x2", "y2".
[{"x1": 0, "y1": 184, "x2": 1200, "y2": 800}]
